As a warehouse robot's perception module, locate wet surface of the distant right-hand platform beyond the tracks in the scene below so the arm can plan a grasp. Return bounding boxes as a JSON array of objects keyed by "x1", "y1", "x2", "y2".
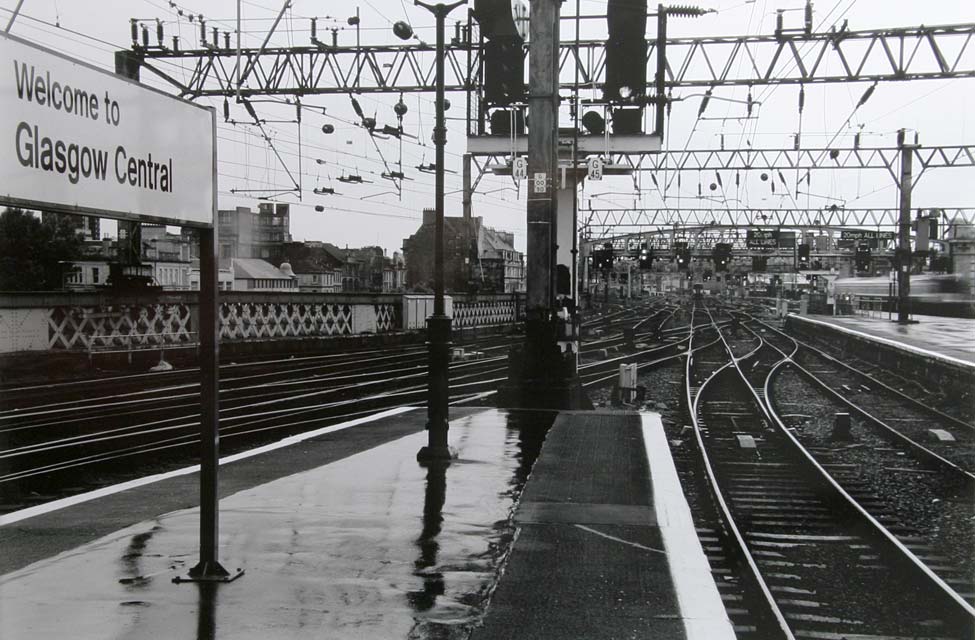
[{"x1": 792, "y1": 315, "x2": 975, "y2": 367}]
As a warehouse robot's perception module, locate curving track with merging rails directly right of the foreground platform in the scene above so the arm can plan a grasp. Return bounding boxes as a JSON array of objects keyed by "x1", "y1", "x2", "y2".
[{"x1": 686, "y1": 304, "x2": 975, "y2": 639}]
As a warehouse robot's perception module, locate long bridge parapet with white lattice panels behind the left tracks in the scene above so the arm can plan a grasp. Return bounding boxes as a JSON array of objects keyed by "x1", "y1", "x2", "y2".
[{"x1": 0, "y1": 291, "x2": 524, "y2": 353}]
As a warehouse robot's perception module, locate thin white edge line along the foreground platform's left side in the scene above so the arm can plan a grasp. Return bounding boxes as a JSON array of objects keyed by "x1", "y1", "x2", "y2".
[{"x1": 0, "y1": 407, "x2": 417, "y2": 527}]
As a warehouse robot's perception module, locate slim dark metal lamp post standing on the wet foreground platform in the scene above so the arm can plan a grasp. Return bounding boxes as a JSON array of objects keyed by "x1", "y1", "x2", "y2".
[{"x1": 414, "y1": 0, "x2": 467, "y2": 463}]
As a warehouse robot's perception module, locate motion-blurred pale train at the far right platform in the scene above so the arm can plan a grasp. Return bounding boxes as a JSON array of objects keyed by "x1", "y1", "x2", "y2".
[{"x1": 830, "y1": 274, "x2": 975, "y2": 318}]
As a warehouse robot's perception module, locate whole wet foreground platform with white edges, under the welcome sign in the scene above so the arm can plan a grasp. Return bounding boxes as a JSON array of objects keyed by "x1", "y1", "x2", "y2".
[{"x1": 0, "y1": 407, "x2": 733, "y2": 640}]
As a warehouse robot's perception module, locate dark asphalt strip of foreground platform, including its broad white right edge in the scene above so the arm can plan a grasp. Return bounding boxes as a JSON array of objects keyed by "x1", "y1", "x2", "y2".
[{"x1": 471, "y1": 411, "x2": 735, "y2": 640}]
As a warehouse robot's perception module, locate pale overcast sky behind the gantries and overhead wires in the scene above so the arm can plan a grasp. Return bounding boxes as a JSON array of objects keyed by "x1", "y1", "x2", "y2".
[{"x1": 0, "y1": 0, "x2": 975, "y2": 252}]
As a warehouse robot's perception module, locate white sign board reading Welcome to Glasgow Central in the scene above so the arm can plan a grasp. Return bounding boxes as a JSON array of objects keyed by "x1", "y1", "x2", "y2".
[{"x1": 0, "y1": 34, "x2": 216, "y2": 226}]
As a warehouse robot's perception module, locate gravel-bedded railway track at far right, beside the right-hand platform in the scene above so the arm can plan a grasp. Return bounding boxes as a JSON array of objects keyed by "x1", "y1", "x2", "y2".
[{"x1": 724, "y1": 323, "x2": 975, "y2": 603}]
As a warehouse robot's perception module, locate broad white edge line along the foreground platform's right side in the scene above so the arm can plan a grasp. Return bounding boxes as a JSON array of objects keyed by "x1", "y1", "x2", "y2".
[{"x1": 640, "y1": 413, "x2": 735, "y2": 640}]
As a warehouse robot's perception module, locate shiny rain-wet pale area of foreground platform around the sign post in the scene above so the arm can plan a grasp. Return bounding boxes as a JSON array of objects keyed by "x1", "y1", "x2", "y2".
[{"x1": 0, "y1": 410, "x2": 554, "y2": 640}]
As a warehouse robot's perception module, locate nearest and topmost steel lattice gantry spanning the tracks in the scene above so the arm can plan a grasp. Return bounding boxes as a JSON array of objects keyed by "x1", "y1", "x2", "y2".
[{"x1": 132, "y1": 24, "x2": 975, "y2": 98}]
